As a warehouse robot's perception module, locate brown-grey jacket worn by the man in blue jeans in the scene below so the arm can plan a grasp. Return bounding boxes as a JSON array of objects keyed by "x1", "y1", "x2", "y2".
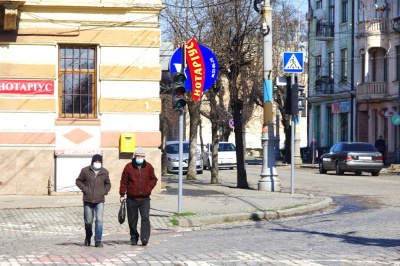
[{"x1": 75, "y1": 165, "x2": 111, "y2": 203}]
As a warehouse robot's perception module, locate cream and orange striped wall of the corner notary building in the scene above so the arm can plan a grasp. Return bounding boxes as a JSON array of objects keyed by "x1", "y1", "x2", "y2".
[{"x1": 0, "y1": 0, "x2": 163, "y2": 195}]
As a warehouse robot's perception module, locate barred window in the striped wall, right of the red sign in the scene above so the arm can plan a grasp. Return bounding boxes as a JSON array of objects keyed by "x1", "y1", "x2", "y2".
[{"x1": 59, "y1": 45, "x2": 97, "y2": 119}]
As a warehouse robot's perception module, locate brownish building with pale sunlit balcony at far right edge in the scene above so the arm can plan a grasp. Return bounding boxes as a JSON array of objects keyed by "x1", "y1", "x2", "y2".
[{"x1": 354, "y1": 0, "x2": 400, "y2": 164}]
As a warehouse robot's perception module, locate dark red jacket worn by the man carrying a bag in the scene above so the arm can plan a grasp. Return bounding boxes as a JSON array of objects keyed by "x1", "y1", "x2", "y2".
[{"x1": 119, "y1": 159, "x2": 158, "y2": 200}]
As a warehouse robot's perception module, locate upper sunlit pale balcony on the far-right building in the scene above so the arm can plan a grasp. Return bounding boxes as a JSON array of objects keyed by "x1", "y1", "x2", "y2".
[{"x1": 356, "y1": 18, "x2": 393, "y2": 38}]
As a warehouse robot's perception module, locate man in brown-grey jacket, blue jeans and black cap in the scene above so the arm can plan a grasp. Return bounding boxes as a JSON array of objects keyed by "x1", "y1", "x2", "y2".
[{"x1": 75, "y1": 154, "x2": 111, "y2": 247}]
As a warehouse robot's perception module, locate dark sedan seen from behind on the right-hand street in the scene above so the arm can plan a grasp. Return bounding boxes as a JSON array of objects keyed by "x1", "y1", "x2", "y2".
[{"x1": 319, "y1": 142, "x2": 383, "y2": 176}]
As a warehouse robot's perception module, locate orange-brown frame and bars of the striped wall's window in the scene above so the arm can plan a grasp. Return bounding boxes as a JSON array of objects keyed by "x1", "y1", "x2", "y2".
[{"x1": 58, "y1": 44, "x2": 98, "y2": 119}]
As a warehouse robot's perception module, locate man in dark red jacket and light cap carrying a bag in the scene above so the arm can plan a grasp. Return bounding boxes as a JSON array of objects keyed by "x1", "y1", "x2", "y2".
[{"x1": 119, "y1": 148, "x2": 158, "y2": 246}]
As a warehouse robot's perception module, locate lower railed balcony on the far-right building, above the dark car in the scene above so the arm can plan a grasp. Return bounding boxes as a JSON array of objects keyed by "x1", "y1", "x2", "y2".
[{"x1": 357, "y1": 82, "x2": 390, "y2": 100}]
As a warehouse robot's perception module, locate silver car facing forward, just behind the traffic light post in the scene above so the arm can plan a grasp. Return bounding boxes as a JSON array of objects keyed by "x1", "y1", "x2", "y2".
[{"x1": 165, "y1": 141, "x2": 203, "y2": 174}]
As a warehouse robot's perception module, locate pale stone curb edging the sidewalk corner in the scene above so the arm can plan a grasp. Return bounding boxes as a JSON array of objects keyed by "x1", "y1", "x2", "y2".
[{"x1": 176, "y1": 198, "x2": 333, "y2": 227}]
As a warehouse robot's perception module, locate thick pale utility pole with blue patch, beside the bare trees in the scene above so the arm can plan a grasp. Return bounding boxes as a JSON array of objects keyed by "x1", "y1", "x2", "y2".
[{"x1": 254, "y1": 0, "x2": 281, "y2": 191}]
